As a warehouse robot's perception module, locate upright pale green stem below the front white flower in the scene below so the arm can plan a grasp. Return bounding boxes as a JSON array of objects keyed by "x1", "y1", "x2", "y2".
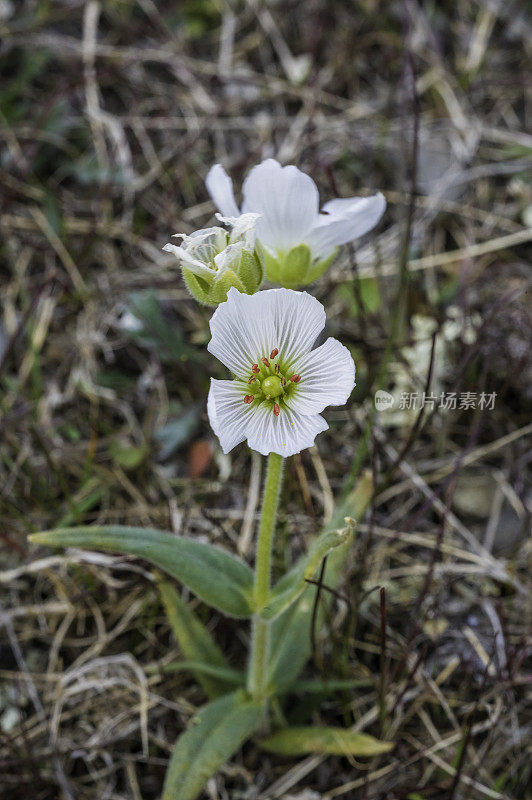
[{"x1": 248, "y1": 453, "x2": 284, "y2": 700}]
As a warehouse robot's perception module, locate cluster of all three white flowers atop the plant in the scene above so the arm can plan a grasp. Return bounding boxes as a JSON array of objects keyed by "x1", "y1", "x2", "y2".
[{"x1": 165, "y1": 159, "x2": 386, "y2": 456}]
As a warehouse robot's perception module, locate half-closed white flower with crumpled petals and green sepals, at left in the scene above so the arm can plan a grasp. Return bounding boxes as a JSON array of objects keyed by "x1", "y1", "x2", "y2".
[{"x1": 163, "y1": 214, "x2": 263, "y2": 306}]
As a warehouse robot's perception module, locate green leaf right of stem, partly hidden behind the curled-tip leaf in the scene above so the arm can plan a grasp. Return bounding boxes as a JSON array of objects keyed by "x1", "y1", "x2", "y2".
[{"x1": 269, "y1": 471, "x2": 373, "y2": 689}]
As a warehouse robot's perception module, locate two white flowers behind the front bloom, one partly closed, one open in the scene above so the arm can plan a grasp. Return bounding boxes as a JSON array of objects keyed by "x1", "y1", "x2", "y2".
[{"x1": 164, "y1": 158, "x2": 386, "y2": 296}]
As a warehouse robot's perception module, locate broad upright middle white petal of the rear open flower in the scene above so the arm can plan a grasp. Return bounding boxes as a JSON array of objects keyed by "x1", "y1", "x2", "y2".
[{"x1": 242, "y1": 158, "x2": 319, "y2": 250}]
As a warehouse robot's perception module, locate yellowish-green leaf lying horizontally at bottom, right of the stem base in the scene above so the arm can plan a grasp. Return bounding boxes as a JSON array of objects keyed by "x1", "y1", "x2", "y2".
[{"x1": 260, "y1": 725, "x2": 395, "y2": 756}]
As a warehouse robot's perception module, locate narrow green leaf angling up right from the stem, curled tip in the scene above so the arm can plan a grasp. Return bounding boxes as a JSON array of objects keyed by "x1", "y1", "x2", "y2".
[{"x1": 260, "y1": 518, "x2": 355, "y2": 619}]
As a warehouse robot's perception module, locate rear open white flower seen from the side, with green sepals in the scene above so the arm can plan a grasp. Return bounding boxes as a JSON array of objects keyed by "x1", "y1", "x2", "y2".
[{"x1": 205, "y1": 158, "x2": 386, "y2": 286}]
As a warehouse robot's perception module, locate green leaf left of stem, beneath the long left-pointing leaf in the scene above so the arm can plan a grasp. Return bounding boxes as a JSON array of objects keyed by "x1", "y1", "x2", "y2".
[{"x1": 157, "y1": 577, "x2": 234, "y2": 697}]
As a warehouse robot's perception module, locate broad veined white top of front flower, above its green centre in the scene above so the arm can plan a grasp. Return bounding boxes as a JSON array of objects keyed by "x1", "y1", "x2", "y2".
[{"x1": 207, "y1": 287, "x2": 325, "y2": 379}]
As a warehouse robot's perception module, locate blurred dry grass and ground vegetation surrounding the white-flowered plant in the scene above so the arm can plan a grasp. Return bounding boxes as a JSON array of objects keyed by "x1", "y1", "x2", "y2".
[{"x1": 0, "y1": 0, "x2": 532, "y2": 800}]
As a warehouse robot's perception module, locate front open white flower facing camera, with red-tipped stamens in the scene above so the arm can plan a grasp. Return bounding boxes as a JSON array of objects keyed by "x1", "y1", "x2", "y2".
[{"x1": 208, "y1": 289, "x2": 355, "y2": 456}]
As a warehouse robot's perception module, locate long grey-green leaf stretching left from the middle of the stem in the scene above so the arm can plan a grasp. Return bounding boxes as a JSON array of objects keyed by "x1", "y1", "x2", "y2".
[{"x1": 29, "y1": 525, "x2": 253, "y2": 619}]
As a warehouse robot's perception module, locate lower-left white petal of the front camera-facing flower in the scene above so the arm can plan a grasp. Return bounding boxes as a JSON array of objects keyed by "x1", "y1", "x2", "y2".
[{"x1": 207, "y1": 378, "x2": 251, "y2": 453}]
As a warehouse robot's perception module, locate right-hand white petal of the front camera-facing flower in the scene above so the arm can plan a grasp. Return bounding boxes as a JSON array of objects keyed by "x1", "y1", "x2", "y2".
[{"x1": 288, "y1": 339, "x2": 355, "y2": 414}]
